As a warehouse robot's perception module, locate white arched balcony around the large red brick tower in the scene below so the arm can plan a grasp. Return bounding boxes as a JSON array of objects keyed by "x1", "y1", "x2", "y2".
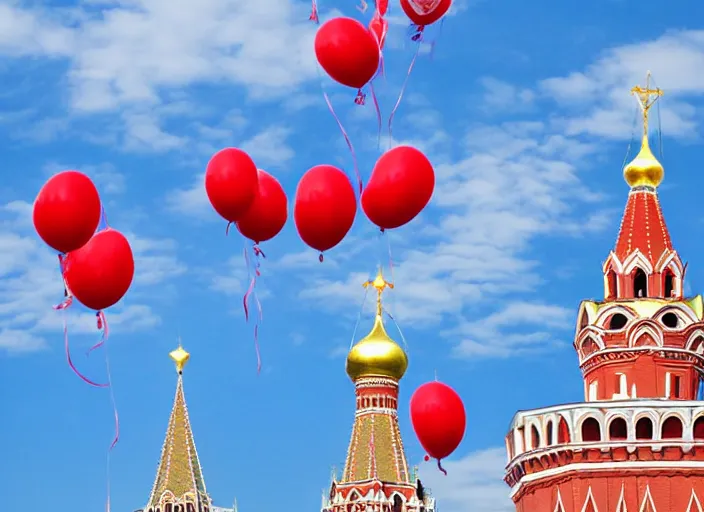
[{"x1": 504, "y1": 400, "x2": 704, "y2": 496}]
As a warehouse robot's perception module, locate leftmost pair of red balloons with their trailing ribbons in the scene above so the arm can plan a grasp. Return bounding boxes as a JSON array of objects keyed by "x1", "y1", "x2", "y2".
[{"x1": 32, "y1": 171, "x2": 134, "y2": 387}]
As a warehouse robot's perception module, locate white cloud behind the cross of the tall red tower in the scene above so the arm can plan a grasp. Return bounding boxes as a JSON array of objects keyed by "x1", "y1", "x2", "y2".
[{"x1": 538, "y1": 30, "x2": 704, "y2": 140}]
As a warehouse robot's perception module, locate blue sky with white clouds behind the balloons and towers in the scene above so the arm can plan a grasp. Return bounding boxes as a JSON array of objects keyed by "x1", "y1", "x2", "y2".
[{"x1": 0, "y1": 0, "x2": 704, "y2": 512}]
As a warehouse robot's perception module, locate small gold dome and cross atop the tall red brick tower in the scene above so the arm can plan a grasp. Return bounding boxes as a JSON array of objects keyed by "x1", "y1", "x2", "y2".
[{"x1": 623, "y1": 71, "x2": 665, "y2": 188}]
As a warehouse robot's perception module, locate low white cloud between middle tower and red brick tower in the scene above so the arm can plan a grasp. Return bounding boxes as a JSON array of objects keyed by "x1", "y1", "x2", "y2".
[{"x1": 419, "y1": 448, "x2": 516, "y2": 512}]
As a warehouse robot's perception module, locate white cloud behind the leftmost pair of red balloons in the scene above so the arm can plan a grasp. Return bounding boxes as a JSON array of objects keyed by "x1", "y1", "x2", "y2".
[{"x1": 0, "y1": 201, "x2": 185, "y2": 354}]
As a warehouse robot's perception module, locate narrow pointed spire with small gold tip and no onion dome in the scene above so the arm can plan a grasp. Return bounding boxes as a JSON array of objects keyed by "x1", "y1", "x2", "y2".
[{"x1": 144, "y1": 344, "x2": 234, "y2": 512}]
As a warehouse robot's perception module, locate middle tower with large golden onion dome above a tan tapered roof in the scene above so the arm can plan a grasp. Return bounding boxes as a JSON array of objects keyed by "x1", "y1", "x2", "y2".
[{"x1": 322, "y1": 270, "x2": 435, "y2": 512}]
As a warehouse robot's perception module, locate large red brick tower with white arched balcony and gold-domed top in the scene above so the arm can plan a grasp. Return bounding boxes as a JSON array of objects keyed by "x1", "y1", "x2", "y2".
[{"x1": 505, "y1": 74, "x2": 704, "y2": 512}]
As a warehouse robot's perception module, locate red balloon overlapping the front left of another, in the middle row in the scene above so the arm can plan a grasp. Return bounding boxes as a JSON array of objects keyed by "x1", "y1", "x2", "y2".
[{"x1": 205, "y1": 148, "x2": 257, "y2": 222}]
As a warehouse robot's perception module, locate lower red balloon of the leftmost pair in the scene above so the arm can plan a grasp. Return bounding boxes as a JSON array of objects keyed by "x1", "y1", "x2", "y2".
[{"x1": 64, "y1": 228, "x2": 134, "y2": 311}]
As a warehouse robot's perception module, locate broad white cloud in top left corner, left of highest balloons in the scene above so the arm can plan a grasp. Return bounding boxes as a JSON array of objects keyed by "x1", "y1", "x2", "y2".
[{"x1": 0, "y1": 0, "x2": 315, "y2": 112}]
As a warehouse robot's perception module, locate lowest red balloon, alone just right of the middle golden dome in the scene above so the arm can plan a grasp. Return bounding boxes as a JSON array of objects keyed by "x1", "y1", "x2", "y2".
[{"x1": 411, "y1": 381, "x2": 467, "y2": 461}]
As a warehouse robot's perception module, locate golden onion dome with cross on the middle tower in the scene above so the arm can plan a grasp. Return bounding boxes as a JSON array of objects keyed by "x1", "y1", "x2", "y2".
[{"x1": 346, "y1": 271, "x2": 408, "y2": 381}]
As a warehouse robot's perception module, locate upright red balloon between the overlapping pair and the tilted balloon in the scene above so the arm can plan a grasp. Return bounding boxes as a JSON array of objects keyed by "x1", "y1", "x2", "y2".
[{"x1": 293, "y1": 165, "x2": 357, "y2": 252}]
